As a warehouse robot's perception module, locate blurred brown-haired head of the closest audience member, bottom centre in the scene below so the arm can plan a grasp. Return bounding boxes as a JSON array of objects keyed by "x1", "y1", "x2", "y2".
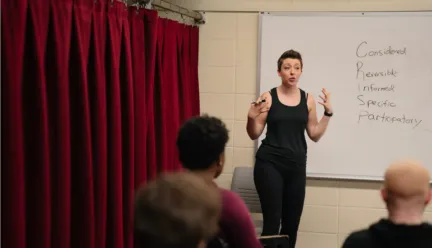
[{"x1": 134, "y1": 171, "x2": 222, "y2": 248}]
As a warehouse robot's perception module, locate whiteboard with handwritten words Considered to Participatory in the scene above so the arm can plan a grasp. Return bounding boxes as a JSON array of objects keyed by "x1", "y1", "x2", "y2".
[{"x1": 256, "y1": 12, "x2": 432, "y2": 180}]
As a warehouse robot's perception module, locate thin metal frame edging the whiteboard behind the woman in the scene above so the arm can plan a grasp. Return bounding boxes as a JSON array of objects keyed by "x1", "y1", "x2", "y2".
[{"x1": 254, "y1": 10, "x2": 432, "y2": 183}]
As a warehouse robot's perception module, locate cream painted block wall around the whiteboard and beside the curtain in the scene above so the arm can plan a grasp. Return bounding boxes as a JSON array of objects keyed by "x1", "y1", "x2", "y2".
[{"x1": 169, "y1": 0, "x2": 432, "y2": 248}]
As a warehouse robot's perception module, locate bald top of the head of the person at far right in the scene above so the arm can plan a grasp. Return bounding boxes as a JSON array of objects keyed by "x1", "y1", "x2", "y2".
[{"x1": 384, "y1": 160, "x2": 430, "y2": 200}]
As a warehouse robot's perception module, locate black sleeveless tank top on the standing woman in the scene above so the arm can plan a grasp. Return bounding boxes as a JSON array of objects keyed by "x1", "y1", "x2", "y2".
[{"x1": 256, "y1": 88, "x2": 309, "y2": 169}]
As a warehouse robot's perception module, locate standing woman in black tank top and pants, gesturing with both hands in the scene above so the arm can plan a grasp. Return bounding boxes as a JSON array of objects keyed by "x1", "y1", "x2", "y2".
[{"x1": 247, "y1": 50, "x2": 333, "y2": 248}]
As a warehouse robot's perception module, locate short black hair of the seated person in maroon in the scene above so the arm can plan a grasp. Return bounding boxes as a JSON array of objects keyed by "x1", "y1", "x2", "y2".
[{"x1": 177, "y1": 114, "x2": 229, "y2": 170}]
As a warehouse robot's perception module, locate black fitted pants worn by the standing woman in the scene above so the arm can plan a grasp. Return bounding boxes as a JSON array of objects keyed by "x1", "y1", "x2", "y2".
[{"x1": 254, "y1": 159, "x2": 306, "y2": 248}]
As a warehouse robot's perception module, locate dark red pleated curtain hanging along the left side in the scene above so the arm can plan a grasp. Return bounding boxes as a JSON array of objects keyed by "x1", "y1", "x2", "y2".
[{"x1": 1, "y1": 0, "x2": 199, "y2": 248}]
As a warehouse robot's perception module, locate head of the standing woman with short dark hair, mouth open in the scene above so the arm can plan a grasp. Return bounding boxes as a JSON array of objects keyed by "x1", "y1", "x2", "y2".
[{"x1": 277, "y1": 50, "x2": 303, "y2": 86}]
